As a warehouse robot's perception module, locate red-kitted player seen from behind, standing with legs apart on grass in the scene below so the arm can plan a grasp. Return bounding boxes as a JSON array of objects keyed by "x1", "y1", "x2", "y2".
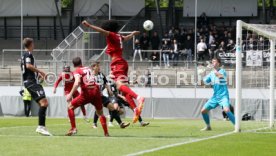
[{"x1": 66, "y1": 57, "x2": 109, "y2": 136}]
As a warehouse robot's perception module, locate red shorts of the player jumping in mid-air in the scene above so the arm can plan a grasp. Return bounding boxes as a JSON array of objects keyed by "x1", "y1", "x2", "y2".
[{"x1": 110, "y1": 57, "x2": 128, "y2": 82}]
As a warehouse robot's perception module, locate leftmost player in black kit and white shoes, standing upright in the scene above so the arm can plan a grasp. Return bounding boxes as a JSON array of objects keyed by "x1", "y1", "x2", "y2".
[{"x1": 21, "y1": 38, "x2": 52, "y2": 136}]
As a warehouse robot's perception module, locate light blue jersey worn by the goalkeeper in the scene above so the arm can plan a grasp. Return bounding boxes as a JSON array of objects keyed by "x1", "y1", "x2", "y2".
[{"x1": 203, "y1": 69, "x2": 229, "y2": 99}]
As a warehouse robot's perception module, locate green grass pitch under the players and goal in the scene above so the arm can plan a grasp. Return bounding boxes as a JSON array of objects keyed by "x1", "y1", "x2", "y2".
[{"x1": 0, "y1": 117, "x2": 276, "y2": 156}]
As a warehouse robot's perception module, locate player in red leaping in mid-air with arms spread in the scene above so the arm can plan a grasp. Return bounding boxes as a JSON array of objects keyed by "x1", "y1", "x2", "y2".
[{"x1": 82, "y1": 20, "x2": 145, "y2": 123}]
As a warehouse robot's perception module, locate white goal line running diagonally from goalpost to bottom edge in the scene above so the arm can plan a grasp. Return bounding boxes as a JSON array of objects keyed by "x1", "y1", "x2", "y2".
[{"x1": 127, "y1": 132, "x2": 235, "y2": 156}]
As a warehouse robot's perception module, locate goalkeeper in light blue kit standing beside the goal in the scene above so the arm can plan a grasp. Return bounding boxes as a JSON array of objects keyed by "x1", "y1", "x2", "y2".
[{"x1": 201, "y1": 58, "x2": 235, "y2": 131}]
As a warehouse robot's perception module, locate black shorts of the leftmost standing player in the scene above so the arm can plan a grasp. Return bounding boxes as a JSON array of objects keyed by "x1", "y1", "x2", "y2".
[{"x1": 24, "y1": 81, "x2": 46, "y2": 103}]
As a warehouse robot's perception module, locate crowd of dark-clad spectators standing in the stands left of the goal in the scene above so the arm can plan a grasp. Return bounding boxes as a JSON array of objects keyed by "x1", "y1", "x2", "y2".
[{"x1": 133, "y1": 13, "x2": 236, "y2": 66}]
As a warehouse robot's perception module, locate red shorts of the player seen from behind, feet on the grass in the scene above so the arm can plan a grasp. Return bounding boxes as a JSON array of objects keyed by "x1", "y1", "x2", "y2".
[{"x1": 71, "y1": 86, "x2": 103, "y2": 110}]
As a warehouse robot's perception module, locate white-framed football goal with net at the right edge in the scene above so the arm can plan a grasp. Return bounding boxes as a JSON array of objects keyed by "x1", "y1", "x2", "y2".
[{"x1": 235, "y1": 20, "x2": 276, "y2": 132}]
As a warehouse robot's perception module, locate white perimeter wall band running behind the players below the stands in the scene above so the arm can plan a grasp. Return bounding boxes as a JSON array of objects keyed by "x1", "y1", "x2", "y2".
[{"x1": 0, "y1": 86, "x2": 269, "y2": 99}]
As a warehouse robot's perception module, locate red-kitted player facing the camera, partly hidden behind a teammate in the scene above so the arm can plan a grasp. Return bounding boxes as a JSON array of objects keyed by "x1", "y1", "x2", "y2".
[{"x1": 53, "y1": 66, "x2": 89, "y2": 122}]
